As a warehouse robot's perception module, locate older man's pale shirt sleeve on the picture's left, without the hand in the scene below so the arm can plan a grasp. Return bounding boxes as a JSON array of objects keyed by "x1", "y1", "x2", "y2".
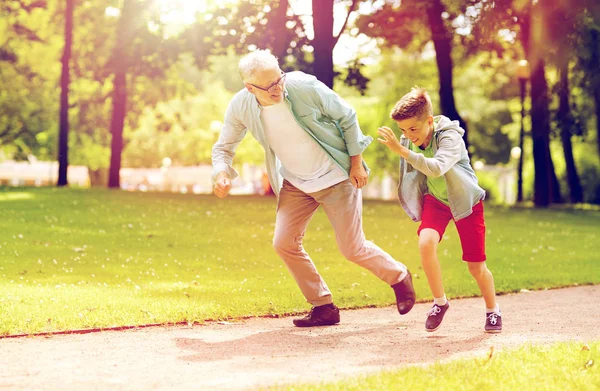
[{"x1": 212, "y1": 101, "x2": 247, "y2": 181}]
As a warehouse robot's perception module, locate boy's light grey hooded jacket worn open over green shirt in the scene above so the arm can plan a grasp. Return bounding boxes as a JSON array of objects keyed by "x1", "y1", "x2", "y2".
[{"x1": 398, "y1": 115, "x2": 485, "y2": 221}]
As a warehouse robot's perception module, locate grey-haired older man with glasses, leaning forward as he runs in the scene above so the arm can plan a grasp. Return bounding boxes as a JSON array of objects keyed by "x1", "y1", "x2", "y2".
[{"x1": 212, "y1": 50, "x2": 415, "y2": 327}]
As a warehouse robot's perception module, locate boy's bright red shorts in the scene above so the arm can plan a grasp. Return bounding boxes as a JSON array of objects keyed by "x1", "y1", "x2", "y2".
[{"x1": 417, "y1": 194, "x2": 486, "y2": 262}]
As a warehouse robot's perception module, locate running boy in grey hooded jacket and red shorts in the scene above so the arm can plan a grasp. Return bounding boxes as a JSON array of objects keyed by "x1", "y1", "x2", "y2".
[{"x1": 378, "y1": 88, "x2": 502, "y2": 333}]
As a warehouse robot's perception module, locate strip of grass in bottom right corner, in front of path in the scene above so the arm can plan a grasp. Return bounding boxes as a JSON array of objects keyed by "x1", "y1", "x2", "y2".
[{"x1": 271, "y1": 342, "x2": 600, "y2": 391}]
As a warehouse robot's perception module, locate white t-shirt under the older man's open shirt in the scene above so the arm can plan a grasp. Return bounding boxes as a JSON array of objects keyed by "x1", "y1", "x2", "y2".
[{"x1": 260, "y1": 101, "x2": 348, "y2": 193}]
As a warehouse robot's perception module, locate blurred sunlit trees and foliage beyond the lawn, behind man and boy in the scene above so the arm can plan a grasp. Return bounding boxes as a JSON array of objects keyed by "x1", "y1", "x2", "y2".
[{"x1": 0, "y1": 0, "x2": 600, "y2": 207}]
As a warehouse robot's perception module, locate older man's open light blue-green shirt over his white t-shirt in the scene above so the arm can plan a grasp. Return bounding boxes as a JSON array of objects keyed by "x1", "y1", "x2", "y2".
[{"x1": 212, "y1": 72, "x2": 373, "y2": 195}]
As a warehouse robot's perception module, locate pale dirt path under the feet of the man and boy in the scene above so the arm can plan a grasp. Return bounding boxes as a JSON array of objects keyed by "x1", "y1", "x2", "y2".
[{"x1": 0, "y1": 285, "x2": 600, "y2": 390}]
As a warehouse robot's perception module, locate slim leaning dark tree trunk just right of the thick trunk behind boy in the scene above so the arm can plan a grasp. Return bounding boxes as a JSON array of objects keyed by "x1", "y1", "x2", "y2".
[{"x1": 558, "y1": 61, "x2": 583, "y2": 203}]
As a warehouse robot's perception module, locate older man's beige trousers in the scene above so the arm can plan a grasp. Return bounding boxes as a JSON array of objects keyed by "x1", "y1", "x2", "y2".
[{"x1": 273, "y1": 180, "x2": 407, "y2": 306}]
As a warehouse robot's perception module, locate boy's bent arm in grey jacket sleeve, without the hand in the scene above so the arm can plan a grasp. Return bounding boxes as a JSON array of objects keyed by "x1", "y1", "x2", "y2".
[{"x1": 400, "y1": 131, "x2": 465, "y2": 178}]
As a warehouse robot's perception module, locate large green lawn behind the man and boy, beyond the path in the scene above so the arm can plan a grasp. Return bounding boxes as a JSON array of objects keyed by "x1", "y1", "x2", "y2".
[{"x1": 0, "y1": 188, "x2": 600, "y2": 335}]
